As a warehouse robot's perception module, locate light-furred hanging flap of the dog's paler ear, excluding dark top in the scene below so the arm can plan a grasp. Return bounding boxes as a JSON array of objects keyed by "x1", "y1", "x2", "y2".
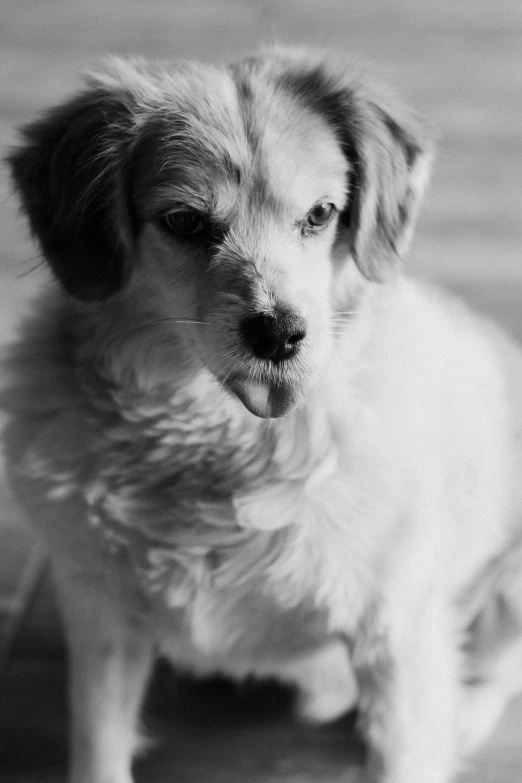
[{"x1": 341, "y1": 77, "x2": 433, "y2": 280}]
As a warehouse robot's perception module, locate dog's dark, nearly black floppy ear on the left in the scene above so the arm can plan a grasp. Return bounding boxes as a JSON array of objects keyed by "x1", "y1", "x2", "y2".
[{"x1": 8, "y1": 78, "x2": 137, "y2": 301}]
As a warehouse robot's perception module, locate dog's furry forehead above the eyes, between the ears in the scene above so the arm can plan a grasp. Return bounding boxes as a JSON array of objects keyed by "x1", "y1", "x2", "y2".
[{"x1": 133, "y1": 61, "x2": 348, "y2": 214}]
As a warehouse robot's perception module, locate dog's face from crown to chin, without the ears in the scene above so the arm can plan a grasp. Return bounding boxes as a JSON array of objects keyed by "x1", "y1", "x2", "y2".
[{"x1": 133, "y1": 65, "x2": 348, "y2": 416}]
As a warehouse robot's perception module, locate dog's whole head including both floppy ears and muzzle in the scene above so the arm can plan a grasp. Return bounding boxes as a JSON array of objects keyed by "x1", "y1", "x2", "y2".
[{"x1": 10, "y1": 50, "x2": 430, "y2": 417}]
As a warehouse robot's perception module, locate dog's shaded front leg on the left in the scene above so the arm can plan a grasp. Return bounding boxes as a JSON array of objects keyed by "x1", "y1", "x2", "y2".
[{"x1": 53, "y1": 571, "x2": 153, "y2": 783}]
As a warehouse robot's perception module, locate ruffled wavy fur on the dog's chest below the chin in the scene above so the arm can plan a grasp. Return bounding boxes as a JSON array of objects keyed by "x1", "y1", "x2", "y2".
[{"x1": 11, "y1": 376, "x2": 370, "y2": 663}]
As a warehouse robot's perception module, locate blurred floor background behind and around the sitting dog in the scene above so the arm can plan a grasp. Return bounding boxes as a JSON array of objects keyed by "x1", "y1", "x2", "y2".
[{"x1": 0, "y1": 0, "x2": 522, "y2": 783}]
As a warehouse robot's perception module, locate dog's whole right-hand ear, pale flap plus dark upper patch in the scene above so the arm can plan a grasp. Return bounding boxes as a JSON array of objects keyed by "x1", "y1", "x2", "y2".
[{"x1": 277, "y1": 59, "x2": 431, "y2": 280}]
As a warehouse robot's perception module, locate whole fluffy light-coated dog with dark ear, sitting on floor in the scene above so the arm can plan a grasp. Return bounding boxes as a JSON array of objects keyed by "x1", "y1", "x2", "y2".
[{"x1": 2, "y1": 48, "x2": 522, "y2": 783}]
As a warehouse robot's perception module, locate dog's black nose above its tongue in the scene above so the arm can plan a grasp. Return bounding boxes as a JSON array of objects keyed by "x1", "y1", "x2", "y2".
[{"x1": 241, "y1": 313, "x2": 306, "y2": 362}]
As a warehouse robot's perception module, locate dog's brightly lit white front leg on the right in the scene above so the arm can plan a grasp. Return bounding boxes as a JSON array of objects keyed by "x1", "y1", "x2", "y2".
[{"x1": 354, "y1": 595, "x2": 459, "y2": 783}]
